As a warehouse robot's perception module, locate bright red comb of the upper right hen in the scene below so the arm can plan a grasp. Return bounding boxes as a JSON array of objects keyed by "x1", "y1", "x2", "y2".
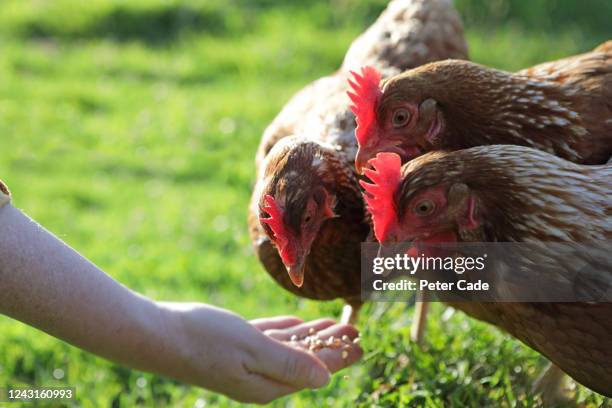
[{"x1": 347, "y1": 67, "x2": 382, "y2": 145}]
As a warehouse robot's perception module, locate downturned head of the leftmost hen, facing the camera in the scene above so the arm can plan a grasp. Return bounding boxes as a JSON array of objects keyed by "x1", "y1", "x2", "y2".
[{"x1": 258, "y1": 138, "x2": 336, "y2": 287}]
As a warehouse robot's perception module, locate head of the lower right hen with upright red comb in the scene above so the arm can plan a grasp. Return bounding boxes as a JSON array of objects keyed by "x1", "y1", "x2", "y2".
[{"x1": 361, "y1": 152, "x2": 481, "y2": 244}]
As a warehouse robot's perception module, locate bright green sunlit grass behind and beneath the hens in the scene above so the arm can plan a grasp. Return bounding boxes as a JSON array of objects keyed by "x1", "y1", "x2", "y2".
[{"x1": 0, "y1": 0, "x2": 612, "y2": 407}]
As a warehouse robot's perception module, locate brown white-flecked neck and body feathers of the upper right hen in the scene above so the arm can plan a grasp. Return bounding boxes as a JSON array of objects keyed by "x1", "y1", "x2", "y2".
[{"x1": 378, "y1": 42, "x2": 612, "y2": 164}]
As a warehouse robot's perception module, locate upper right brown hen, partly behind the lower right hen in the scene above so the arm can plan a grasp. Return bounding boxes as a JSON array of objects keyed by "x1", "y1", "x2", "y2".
[{"x1": 353, "y1": 41, "x2": 612, "y2": 171}]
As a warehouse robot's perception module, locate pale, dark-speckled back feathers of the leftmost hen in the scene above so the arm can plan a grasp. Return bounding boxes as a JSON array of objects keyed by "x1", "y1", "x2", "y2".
[{"x1": 256, "y1": 0, "x2": 468, "y2": 164}]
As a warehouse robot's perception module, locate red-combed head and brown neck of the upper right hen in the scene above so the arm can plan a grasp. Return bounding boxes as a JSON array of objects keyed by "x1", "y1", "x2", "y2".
[{"x1": 349, "y1": 60, "x2": 582, "y2": 173}]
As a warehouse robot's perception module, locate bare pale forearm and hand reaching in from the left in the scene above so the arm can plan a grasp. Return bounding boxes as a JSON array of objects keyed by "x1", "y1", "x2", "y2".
[{"x1": 0, "y1": 203, "x2": 362, "y2": 403}]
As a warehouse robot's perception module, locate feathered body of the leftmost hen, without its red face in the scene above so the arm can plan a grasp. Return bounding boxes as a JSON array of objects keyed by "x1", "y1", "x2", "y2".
[{"x1": 249, "y1": 0, "x2": 467, "y2": 306}]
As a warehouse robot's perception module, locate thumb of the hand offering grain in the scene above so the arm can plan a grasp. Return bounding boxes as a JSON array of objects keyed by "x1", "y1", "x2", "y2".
[{"x1": 254, "y1": 337, "x2": 330, "y2": 389}]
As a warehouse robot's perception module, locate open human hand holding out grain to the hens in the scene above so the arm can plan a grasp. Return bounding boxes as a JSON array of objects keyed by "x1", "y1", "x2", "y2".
[{"x1": 160, "y1": 303, "x2": 361, "y2": 403}]
